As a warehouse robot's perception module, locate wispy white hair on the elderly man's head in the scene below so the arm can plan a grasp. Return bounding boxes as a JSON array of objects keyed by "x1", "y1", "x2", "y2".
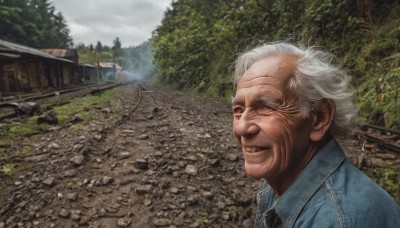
[{"x1": 233, "y1": 42, "x2": 358, "y2": 136}]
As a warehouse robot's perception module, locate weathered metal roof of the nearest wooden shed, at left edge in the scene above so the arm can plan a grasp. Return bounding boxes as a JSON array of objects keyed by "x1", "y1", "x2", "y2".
[{"x1": 0, "y1": 40, "x2": 74, "y2": 63}]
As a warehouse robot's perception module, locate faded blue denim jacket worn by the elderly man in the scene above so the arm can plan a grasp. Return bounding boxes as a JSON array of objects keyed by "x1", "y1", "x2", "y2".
[{"x1": 255, "y1": 139, "x2": 400, "y2": 228}]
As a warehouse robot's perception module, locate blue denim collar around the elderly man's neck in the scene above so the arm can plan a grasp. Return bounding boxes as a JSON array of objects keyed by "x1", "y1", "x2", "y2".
[{"x1": 275, "y1": 139, "x2": 345, "y2": 227}]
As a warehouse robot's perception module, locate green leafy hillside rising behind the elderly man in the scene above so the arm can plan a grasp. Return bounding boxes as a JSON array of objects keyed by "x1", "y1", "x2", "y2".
[{"x1": 153, "y1": 0, "x2": 400, "y2": 129}]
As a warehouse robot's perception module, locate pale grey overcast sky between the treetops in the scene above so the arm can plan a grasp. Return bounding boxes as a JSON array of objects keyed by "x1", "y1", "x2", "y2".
[{"x1": 53, "y1": 0, "x2": 171, "y2": 47}]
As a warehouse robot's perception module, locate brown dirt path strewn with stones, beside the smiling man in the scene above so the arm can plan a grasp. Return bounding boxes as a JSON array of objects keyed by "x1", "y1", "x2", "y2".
[{"x1": 0, "y1": 85, "x2": 257, "y2": 227}]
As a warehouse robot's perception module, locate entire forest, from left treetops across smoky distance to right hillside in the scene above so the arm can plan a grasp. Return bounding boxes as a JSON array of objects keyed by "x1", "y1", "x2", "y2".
[{"x1": 0, "y1": 0, "x2": 400, "y2": 130}]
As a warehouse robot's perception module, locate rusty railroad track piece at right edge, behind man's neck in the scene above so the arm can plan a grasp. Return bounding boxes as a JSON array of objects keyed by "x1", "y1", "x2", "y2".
[{"x1": 355, "y1": 124, "x2": 400, "y2": 153}]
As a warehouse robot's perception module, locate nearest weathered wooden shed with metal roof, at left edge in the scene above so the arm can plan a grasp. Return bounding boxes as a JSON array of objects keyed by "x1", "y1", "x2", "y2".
[{"x1": 0, "y1": 40, "x2": 75, "y2": 94}]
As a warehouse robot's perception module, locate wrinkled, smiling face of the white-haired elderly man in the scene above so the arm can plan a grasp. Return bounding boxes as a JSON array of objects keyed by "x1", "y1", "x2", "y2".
[{"x1": 233, "y1": 55, "x2": 312, "y2": 185}]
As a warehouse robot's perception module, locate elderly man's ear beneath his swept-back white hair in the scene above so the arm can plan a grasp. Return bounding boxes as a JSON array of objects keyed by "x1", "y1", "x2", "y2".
[{"x1": 310, "y1": 98, "x2": 336, "y2": 142}]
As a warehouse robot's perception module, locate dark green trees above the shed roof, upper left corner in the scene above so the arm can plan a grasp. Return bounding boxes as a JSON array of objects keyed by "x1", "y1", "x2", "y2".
[{"x1": 0, "y1": 0, "x2": 72, "y2": 48}]
